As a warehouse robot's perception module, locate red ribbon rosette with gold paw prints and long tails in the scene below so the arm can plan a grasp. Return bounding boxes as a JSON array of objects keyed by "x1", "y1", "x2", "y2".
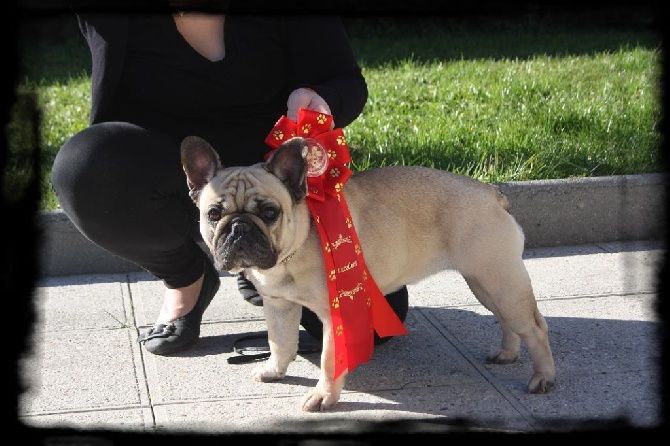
[{"x1": 265, "y1": 109, "x2": 407, "y2": 379}]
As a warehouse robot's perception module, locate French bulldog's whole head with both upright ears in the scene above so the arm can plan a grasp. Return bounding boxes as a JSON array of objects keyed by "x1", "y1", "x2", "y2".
[{"x1": 181, "y1": 136, "x2": 309, "y2": 273}]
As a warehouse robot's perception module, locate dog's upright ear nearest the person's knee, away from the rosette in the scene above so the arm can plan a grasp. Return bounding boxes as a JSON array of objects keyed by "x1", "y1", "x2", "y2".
[{"x1": 181, "y1": 136, "x2": 222, "y2": 203}]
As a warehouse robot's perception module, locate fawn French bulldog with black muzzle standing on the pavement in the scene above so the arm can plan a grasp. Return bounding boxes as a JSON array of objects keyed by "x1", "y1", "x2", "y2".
[{"x1": 181, "y1": 136, "x2": 556, "y2": 412}]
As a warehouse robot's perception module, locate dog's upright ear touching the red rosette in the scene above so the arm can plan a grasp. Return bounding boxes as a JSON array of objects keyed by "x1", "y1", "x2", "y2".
[{"x1": 265, "y1": 136, "x2": 309, "y2": 201}]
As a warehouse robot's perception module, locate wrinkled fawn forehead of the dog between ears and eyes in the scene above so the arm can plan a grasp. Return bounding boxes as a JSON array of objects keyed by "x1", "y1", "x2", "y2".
[{"x1": 200, "y1": 167, "x2": 290, "y2": 213}]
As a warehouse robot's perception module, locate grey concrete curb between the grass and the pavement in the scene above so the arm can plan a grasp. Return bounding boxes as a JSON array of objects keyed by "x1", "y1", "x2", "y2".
[{"x1": 38, "y1": 174, "x2": 668, "y2": 277}]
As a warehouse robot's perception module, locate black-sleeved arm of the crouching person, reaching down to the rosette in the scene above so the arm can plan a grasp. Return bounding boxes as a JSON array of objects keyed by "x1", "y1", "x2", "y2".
[{"x1": 286, "y1": 15, "x2": 368, "y2": 127}]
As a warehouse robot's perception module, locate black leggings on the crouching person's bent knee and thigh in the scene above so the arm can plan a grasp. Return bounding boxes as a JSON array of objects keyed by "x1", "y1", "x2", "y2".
[{"x1": 51, "y1": 122, "x2": 209, "y2": 288}]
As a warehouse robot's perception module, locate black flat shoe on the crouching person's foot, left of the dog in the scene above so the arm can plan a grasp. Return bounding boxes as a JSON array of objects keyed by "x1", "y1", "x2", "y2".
[{"x1": 139, "y1": 262, "x2": 221, "y2": 356}]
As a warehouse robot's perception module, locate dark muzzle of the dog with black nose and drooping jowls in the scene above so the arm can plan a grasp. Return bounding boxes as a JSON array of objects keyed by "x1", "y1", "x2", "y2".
[{"x1": 212, "y1": 216, "x2": 277, "y2": 272}]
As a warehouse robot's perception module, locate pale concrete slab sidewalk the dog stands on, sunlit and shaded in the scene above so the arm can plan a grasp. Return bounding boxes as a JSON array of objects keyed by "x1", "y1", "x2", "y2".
[{"x1": 19, "y1": 242, "x2": 664, "y2": 435}]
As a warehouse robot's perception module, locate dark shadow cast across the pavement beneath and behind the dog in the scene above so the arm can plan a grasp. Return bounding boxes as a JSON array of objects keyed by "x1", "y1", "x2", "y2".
[{"x1": 184, "y1": 307, "x2": 661, "y2": 421}]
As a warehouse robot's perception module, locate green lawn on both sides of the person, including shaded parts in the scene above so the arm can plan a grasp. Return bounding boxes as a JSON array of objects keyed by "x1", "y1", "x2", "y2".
[{"x1": 5, "y1": 13, "x2": 664, "y2": 209}]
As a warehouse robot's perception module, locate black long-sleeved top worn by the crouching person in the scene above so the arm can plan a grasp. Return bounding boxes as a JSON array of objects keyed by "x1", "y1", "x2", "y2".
[{"x1": 78, "y1": 13, "x2": 368, "y2": 165}]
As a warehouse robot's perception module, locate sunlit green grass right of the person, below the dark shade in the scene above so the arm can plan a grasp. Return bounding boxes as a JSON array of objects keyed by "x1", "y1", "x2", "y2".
[{"x1": 347, "y1": 48, "x2": 660, "y2": 182}]
